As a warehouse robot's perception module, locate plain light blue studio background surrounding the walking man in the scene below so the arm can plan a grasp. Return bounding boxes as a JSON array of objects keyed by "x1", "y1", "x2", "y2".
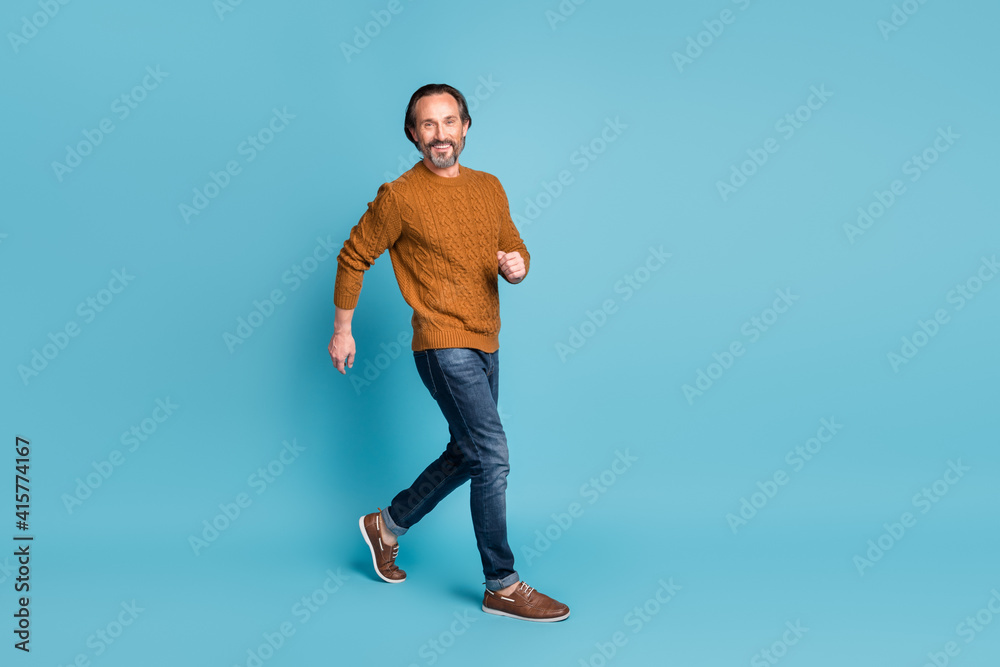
[{"x1": 0, "y1": 0, "x2": 1000, "y2": 667}]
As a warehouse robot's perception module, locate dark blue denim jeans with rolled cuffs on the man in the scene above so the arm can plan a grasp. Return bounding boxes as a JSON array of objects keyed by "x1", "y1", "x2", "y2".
[{"x1": 382, "y1": 348, "x2": 519, "y2": 591}]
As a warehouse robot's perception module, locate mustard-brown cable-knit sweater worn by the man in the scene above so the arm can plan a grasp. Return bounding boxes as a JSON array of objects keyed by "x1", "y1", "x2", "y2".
[{"x1": 333, "y1": 162, "x2": 530, "y2": 352}]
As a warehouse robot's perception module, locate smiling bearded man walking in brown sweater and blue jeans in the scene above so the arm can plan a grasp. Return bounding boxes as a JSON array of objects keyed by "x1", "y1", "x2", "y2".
[{"x1": 329, "y1": 84, "x2": 569, "y2": 621}]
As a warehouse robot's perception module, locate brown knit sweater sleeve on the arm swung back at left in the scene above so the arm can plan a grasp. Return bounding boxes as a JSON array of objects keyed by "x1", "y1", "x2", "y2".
[{"x1": 333, "y1": 183, "x2": 402, "y2": 310}]
